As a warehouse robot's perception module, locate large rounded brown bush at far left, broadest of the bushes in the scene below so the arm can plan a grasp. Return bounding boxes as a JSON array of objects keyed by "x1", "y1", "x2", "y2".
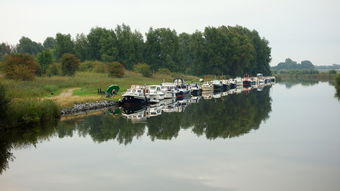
[{"x1": 4, "y1": 54, "x2": 39, "y2": 80}]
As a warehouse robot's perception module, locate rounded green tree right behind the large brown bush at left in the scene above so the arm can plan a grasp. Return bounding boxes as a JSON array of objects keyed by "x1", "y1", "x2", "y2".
[{"x1": 16, "y1": 37, "x2": 44, "y2": 55}]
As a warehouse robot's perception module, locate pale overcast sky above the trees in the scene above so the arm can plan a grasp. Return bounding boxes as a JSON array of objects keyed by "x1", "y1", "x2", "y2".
[{"x1": 0, "y1": 0, "x2": 340, "y2": 65}]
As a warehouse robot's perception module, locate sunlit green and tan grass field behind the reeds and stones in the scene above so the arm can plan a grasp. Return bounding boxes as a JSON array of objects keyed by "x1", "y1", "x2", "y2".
[{"x1": 0, "y1": 71, "x2": 198, "y2": 107}]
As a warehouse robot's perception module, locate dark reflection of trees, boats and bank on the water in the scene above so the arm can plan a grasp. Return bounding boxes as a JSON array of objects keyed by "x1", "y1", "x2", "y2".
[{"x1": 0, "y1": 86, "x2": 271, "y2": 172}]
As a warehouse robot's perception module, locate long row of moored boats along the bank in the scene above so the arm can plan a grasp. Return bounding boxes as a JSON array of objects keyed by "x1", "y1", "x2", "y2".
[{"x1": 120, "y1": 74, "x2": 275, "y2": 107}]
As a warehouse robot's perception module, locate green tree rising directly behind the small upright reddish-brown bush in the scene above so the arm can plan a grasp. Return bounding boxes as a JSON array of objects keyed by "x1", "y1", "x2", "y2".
[{"x1": 55, "y1": 33, "x2": 74, "y2": 58}]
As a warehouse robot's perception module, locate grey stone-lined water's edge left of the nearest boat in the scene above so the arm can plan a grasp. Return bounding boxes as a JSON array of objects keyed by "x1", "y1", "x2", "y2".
[{"x1": 60, "y1": 100, "x2": 118, "y2": 116}]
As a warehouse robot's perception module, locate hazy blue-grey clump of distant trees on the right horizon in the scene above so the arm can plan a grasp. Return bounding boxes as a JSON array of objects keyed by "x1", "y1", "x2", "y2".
[{"x1": 272, "y1": 58, "x2": 315, "y2": 70}]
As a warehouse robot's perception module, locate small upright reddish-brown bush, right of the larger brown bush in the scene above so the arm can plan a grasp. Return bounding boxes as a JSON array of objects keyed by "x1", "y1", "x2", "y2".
[{"x1": 61, "y1": 53, "x2": 80, "y2": 76}]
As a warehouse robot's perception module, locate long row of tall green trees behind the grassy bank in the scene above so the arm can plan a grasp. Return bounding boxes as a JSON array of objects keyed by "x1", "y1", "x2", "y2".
[{"x1": 0, "y1": 24, "x2": 271, "y2": 76}]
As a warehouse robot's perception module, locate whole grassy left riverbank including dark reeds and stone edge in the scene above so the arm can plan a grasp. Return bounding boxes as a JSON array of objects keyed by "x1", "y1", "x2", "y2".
[{"x1": 0, "y1": 71, "x2": 199, "y2": 128}]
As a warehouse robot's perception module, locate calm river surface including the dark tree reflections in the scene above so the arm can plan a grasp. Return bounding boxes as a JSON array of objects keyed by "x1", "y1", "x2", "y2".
[{"x1": 0, "y1": 82, "x2": 340, "y2": 191}]
